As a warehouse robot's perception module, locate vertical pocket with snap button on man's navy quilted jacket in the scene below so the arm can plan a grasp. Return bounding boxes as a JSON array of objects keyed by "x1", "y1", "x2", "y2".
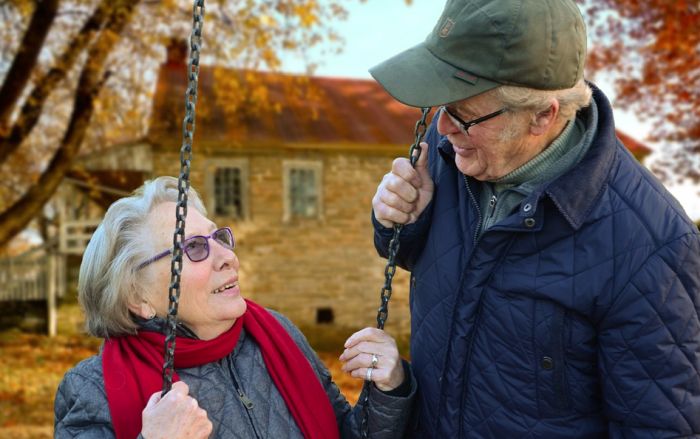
[{"x1": 535, "y1": 301, "x2": 571, "y2": 417}]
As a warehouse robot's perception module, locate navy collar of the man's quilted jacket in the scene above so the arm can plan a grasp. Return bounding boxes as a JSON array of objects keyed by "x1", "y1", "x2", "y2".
[{"x1": 438, "y1": 83, "x2": 617, "y2": 230}]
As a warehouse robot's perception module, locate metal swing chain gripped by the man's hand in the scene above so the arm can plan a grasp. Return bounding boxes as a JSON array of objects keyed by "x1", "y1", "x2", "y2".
[{"x1": 361, "y1": 107, "x2": 430, "y2": 439}]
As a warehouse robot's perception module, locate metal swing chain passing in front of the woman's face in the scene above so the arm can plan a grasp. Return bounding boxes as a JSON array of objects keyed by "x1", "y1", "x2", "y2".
[{"x1": 162, "y1": 0, "x2": 204, "y2": 395}]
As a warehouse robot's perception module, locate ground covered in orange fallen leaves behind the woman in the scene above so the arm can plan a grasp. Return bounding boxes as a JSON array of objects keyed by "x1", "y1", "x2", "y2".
[{"x1": 0, "y1": 305, "x2": 362, "y2": 439}]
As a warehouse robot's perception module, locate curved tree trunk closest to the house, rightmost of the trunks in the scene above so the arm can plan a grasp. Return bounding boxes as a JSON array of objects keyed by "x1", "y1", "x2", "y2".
[{"x1": 0, "y1": 0, "x2": 138, "y2": 246}]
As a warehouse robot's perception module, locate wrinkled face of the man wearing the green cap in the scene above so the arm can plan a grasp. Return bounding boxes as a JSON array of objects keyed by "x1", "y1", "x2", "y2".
[{"x1": 438, "y1": 94, "x2": 542, "y2": 181}]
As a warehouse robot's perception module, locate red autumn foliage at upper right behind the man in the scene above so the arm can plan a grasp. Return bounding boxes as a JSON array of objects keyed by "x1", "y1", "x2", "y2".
[{"x1": 577, "y1": 0, "x2": 700, "y2": 182}]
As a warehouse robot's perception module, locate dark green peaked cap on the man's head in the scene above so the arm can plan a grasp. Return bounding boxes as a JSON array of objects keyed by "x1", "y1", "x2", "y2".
[{"x1": 370, "y1": 0, "x2": 586, "y2": 107}]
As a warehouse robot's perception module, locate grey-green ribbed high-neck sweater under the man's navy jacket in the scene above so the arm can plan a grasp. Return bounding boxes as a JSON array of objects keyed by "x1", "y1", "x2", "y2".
[{"x1": 479, "y1": 101, "x2": 598, "y2": 235}]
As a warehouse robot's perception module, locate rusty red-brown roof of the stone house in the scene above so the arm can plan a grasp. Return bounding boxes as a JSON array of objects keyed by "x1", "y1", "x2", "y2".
[{"x1": 148, "y1": 59, "x2": 651, "y2": 160}]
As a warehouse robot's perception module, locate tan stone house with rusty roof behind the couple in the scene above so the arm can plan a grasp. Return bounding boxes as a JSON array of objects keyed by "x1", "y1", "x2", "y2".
[{"x1": 16, "y1": 46, "x2": 649, "y2": 347}]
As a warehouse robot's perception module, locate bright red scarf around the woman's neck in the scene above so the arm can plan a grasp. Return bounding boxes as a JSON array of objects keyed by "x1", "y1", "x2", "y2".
[{"x1": 102, "y1": 300, "x2": 339, "y2": 439}]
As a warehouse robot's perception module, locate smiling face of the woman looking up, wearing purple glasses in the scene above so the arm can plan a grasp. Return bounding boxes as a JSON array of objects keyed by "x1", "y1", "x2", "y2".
[{"x1": 143, "y1": 202, "x2": 246, "y2": 340}]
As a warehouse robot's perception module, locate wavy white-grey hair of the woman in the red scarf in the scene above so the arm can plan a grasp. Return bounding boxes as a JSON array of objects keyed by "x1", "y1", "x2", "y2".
[{"x1": 78, "y1": 177, "x2": 206, "y2": 338}]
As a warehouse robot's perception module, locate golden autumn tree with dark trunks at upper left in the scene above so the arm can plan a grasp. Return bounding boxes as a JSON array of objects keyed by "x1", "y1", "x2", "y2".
[{"x1": 0, "y1": 0, "x2": 346, "y2": 245}]
